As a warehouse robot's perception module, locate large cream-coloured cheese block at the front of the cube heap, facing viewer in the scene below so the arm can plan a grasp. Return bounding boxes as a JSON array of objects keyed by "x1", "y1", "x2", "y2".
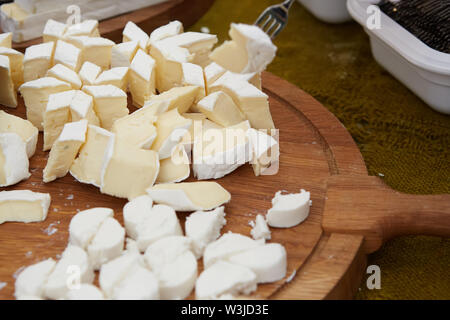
[{"x1": 100, "y1": 140, "x2": 159, "y2": 199}]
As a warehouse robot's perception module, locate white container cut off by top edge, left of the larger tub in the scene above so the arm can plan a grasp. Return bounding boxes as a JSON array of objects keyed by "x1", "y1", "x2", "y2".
[{"x1": 298, "y1": 0, "x2": 352, "y2": 23}]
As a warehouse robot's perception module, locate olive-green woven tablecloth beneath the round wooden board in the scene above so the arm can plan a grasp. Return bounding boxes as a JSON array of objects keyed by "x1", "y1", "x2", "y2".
[{"x1": 191, "y1": 0, "x2": 450, "y2": 299}]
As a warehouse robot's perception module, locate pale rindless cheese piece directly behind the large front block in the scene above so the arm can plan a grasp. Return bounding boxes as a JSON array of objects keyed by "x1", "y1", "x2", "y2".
[{"x1": 111, "y1": 106, "x2": 157, "y2": 149}]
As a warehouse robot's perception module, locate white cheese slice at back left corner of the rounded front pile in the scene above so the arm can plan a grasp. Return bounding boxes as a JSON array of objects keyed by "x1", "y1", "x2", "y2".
[{"x1": 69, "y1": 208, "x2": 114, "y2": 250}]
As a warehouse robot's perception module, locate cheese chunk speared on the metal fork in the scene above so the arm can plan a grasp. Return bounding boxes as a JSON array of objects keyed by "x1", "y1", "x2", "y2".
[{"x1": 210, "y1": 23, "x2": 277, "y2": 73}]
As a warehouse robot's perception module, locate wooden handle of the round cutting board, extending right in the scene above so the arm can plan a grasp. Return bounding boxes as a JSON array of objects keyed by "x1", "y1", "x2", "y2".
[{"x1": 322, "y1": 175, "x2": 450, "y2": 253}]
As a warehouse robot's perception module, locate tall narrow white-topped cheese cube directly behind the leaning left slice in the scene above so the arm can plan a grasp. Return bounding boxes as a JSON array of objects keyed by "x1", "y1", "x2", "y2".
[{"x1": 43, "y1": 90, "x2": 75, "y2": 151}]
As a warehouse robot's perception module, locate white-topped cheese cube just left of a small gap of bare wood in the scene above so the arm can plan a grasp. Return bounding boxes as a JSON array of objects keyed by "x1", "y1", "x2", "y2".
[{"x1": 83, "y1": 84, "x2": 129, "y2": 130}]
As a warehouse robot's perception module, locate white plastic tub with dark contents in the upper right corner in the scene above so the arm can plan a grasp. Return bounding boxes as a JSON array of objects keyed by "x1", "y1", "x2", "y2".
[{"x1": 347, "y1": 0, "x2": 450, "y2": 114}]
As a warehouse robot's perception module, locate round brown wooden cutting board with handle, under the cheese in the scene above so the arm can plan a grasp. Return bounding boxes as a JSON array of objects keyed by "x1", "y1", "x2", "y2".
[{"x1": 0, "y1": 73, "x2": 450, "y2": 299}]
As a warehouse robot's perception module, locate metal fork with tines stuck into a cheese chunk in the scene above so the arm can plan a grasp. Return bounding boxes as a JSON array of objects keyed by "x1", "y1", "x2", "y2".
[{"x1": 255, "y1": 0, "x2": 295, "y2": 40}]
